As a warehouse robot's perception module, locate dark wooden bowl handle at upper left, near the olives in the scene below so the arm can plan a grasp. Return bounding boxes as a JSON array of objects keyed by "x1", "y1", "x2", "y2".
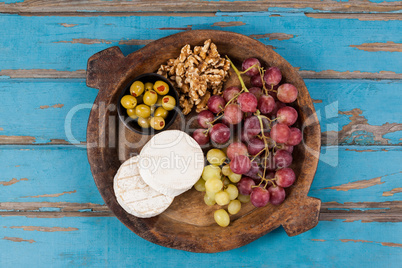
[{"x1": 87, "y1": 46, "x2": 126, "y2": 89}]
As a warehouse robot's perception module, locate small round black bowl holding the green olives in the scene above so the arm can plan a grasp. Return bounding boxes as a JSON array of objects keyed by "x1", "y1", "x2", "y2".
[{"x1": 117, "y1": 73, "x2": 179, "y2": 135}]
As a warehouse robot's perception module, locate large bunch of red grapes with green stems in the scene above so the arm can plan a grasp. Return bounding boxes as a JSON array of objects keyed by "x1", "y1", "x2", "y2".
[{"x1": 193, "y1": 58, "x2": 302, "y2": 222}]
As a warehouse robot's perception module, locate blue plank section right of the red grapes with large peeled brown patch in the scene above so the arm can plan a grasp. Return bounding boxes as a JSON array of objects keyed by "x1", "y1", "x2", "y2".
[{"x1": 305, "y1": 80, "x2": 402, "y2": 145}]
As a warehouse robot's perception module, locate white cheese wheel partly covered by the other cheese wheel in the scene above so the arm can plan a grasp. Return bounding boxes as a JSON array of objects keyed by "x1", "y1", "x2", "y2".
[{"x1": 113, "y1": 156, "x2": 173, "y2": 218}]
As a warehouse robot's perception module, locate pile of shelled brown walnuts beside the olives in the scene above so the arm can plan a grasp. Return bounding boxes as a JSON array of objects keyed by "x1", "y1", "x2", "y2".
[{"x1": 157, "y1": 39, "x2": 230, "y2": 114}]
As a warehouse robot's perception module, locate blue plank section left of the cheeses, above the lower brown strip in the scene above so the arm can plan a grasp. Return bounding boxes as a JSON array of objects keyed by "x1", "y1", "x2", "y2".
[{"x1": 0, "y1": 146, "x2": 103, "y2": 204}]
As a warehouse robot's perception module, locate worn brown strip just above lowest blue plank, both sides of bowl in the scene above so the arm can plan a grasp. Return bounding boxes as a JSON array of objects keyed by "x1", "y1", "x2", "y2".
[{"x1": 0, "y1": 201, "x2": 402, "y2": 222}]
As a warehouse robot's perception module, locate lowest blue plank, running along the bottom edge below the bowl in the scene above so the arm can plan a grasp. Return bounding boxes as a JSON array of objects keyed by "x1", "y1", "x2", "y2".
[{"x1": 0, "y1": 217, "x2": 402, "y2": 267}]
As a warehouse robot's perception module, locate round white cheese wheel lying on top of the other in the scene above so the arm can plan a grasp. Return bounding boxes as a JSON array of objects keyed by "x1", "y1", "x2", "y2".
[{"x1": 138, "y1": 130, "x2": 204, "y2": 197}]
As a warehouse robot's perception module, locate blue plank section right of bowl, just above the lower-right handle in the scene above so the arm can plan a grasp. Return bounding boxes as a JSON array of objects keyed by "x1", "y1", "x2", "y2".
[{"x1": 309, "y1": 146, "x2": 402, "y2": 203}]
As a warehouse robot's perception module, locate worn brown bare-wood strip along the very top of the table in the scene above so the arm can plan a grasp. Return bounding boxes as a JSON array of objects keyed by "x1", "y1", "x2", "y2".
[{"x1": 0, "y1": 0, "x2": 402, "y2": 15}]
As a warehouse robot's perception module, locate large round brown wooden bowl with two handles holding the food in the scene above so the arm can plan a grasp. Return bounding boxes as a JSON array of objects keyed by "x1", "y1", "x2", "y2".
[{"x1": 87, "y1": 30, "x2": 321, "y2": 252}]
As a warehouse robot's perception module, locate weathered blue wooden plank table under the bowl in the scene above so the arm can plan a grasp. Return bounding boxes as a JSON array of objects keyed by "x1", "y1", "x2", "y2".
[{"x1": 0, "y1": 0, "x2": 402, "y2": 267}]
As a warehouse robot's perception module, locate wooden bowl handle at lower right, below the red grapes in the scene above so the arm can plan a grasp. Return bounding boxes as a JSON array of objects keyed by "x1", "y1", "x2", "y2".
[{"x1": 282, "y1": 196, "x2": 321, "y2": 236}]
